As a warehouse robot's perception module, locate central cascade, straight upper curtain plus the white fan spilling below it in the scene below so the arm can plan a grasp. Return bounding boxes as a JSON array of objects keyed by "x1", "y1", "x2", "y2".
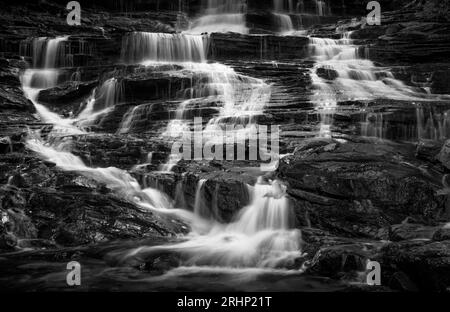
[{"x1": 119, "y1": 33, "x2": 271, "y2": 171}]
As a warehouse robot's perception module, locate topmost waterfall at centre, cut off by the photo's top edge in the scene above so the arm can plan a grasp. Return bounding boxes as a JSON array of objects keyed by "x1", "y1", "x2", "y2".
[{"x1": 187, "y1": 0, "x2": 249, "y2": 34}]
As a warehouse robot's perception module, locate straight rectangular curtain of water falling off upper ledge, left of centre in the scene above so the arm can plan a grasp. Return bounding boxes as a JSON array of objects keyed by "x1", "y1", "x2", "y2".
[{"x1": 121, "y1": 32, "x2": 207, "y2": 64}]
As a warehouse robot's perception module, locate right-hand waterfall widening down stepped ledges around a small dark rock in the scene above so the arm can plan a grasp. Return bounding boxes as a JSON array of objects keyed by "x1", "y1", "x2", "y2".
[{"x1": 309, "y1": 33, "x2": 429, "y2": 136}]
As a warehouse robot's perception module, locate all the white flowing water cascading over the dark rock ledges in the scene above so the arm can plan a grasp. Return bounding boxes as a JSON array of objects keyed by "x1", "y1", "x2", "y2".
[{"x1": 15, "y1": 0, "x2": 446, "y2": 290}]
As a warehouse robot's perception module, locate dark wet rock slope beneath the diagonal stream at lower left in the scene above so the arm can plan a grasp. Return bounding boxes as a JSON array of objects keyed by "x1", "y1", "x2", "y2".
[{"x1": 0, "y1": 151, "x2": 186, "y2": 247}]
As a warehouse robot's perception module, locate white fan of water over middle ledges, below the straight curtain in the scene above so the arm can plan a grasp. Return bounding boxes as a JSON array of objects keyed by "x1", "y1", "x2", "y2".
[{"x1": 158, "y1": 63, "x2": 271, "y2": 171}]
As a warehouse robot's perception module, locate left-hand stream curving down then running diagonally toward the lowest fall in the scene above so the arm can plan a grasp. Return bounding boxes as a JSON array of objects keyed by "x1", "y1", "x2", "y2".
[{"x1": 21, "y1": 37, "x2": 191, "y2": 219}]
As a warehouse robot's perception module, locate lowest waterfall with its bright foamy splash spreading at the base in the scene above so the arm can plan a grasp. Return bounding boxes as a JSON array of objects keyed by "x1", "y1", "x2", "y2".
[{"x1": 125, "y1": 179, "x2": 302, "y2": 271}]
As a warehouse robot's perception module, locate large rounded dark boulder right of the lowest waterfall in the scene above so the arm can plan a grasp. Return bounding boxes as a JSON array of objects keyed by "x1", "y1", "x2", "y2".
[{"x1": 278, "y1": 139, "x2": 448, "y2": 238}]
